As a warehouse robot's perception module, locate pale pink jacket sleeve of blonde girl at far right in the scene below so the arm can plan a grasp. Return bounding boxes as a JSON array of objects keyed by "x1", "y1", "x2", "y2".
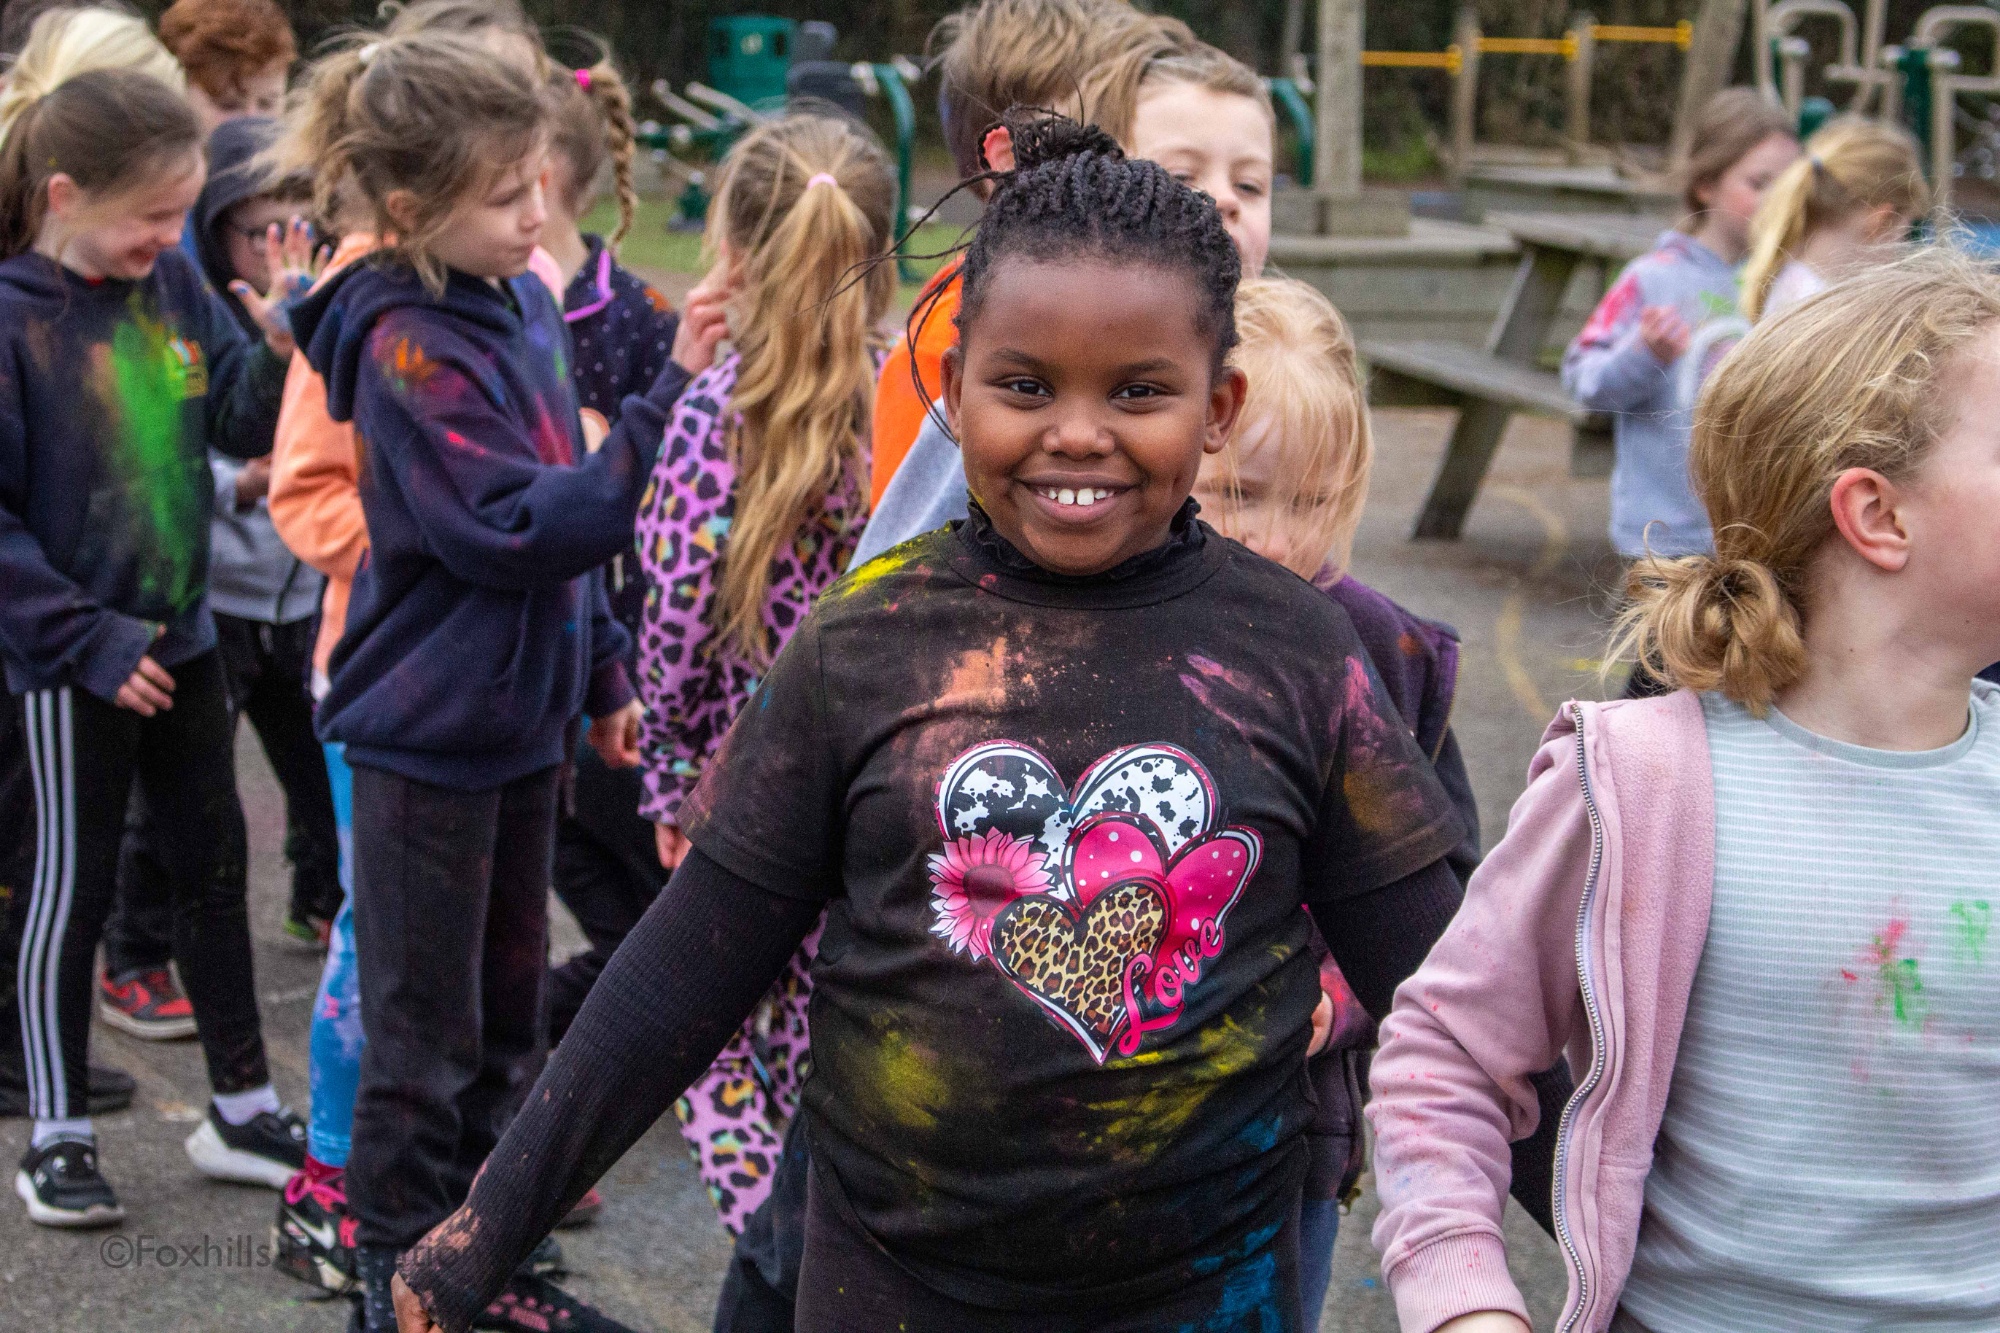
[{"x1": 1360, "y1": 735, "x2": 1592, "y2": 1331}]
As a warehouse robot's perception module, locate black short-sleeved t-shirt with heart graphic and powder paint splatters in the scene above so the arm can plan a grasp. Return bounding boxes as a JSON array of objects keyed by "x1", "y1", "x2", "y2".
[{"x1": 682, "y1": 508, "x2": 1460, "y2": 1309}]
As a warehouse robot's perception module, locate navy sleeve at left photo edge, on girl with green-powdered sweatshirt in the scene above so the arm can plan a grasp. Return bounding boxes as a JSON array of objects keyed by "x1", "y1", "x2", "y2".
[{"x1": 0, "y1": 346, "x2": 156, "y2": 699}]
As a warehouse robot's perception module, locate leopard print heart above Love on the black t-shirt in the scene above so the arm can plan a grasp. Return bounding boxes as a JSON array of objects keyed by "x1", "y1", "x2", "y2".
[{"x1": 992, "y1": 881, "x2": 1166, "y2": 1065}]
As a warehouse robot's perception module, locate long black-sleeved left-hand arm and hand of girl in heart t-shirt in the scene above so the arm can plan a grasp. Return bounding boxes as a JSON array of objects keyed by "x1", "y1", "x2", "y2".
[{"x1": 398, "y1": 849, "x2": 826, "y2": 1333}]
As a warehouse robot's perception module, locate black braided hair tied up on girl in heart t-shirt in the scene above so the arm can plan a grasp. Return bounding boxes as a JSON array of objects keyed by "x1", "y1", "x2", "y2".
[{"x1": 944, "y1": 106, "x2": 1242, "y2": 370}]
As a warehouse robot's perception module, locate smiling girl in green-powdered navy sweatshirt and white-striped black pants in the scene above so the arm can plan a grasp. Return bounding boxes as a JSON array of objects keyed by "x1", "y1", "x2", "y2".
[{"x1": 0, "y1": 67, "x2": 304, "y2": 1227}]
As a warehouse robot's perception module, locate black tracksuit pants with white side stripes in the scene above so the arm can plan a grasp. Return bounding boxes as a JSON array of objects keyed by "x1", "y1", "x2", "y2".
[{"x1": 14, "y1": 652, "x2": 270, "y2": 1119}]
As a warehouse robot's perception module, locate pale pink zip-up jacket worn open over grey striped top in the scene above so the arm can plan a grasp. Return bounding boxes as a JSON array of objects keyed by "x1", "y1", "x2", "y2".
[{"x1": 1368, "y1": 691, "x2": 1716, "y2": 1333}]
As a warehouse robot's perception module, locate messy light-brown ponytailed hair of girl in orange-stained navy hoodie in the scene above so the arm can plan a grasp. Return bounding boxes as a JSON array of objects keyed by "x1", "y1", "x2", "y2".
[{"x1": 270, "y1": 28, "x2": 548, "y2": 292}]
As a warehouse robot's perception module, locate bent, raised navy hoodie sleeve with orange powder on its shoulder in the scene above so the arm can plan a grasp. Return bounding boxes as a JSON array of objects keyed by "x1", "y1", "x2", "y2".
[{"x1": 354, "y1": 312, "x2": 686, "y2": 588}]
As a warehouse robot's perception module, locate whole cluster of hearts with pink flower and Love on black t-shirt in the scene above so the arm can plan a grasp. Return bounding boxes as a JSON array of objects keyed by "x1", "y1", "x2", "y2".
[{"x1": 930, "y1": 741, "x2": 1262, "y2": 1063}]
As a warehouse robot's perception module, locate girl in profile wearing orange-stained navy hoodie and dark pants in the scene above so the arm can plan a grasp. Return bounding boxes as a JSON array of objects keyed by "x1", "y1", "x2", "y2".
[{"x1": 286, "y1": 30, "x2": 686, "y2": 1331}]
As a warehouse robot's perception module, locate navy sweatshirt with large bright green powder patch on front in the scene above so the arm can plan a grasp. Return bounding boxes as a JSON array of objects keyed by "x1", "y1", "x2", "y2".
[{"x1": 0, "y1": 250, "x2": 284, "y2": 699}]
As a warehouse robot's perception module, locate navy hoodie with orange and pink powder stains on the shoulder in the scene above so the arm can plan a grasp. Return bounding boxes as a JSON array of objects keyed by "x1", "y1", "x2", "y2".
[{"x1": 292, "y1": 260, "x2": 686, "y2": 791}]
